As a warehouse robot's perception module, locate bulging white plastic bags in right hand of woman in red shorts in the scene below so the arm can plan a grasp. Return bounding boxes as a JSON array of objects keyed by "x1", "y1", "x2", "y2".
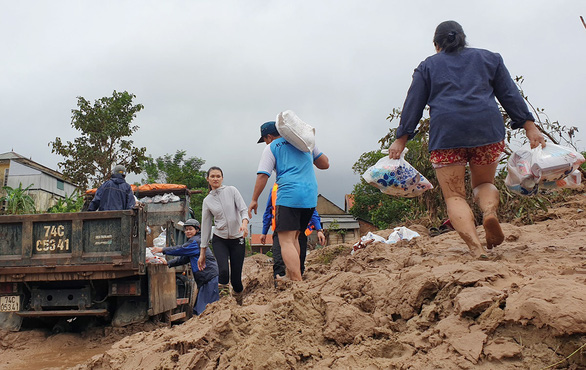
[{"x1": 505, "y1": 143, "x2": 584, "y2": 195}]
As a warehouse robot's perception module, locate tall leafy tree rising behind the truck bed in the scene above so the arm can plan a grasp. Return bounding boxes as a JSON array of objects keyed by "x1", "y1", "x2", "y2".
[{"x1": 49, "y1": 90, "x2": 146, "y2": 188}]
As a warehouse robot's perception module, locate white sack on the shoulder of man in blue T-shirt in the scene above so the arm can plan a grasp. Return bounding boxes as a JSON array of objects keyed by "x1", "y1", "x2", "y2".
[{"x1": 275, "y1": 110, "x2": 315, "y2": 152}]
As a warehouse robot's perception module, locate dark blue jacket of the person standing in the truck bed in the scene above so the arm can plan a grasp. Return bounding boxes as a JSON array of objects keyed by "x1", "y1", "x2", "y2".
[{"x1": 88, "y1": 173, "x2": 135, "y2": 211}]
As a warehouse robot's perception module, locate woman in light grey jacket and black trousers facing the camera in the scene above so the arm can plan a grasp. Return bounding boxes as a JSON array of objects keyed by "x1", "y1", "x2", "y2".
[{"x1": 197, "y1": 167, "x2": 249, "y2": 305}]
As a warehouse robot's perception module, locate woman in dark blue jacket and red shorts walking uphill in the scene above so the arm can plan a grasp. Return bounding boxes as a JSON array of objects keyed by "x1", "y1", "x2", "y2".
[{"x1": 389, "y1": 21, "x2": 545, "y2": 257}]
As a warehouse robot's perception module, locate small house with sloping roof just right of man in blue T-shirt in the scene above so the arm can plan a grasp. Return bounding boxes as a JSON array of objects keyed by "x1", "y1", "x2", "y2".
[{"x1": 314, "y1": 194, "x2": 360, "y2": 245}]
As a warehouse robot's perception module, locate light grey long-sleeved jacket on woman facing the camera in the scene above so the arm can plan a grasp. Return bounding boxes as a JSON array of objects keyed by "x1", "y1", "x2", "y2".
[{"x1": 201, "y1": 185, "x2": 248, "y2": 247}]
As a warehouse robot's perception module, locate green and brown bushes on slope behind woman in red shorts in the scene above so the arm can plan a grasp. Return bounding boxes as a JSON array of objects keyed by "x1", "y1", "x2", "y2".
[{"x1": 350, "y1": 77, "x2": 586, "y2": 228}]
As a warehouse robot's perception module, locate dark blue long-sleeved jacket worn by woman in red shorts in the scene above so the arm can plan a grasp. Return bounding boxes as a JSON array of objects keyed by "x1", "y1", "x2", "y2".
[{"x1": 397, "y1": 48, "x2": 534, "y2": 151}]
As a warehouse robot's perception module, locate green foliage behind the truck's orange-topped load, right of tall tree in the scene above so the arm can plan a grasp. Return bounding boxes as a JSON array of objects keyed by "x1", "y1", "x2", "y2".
[{"x1": 141, "y1": 150, "x2": 208, "y2": 221}]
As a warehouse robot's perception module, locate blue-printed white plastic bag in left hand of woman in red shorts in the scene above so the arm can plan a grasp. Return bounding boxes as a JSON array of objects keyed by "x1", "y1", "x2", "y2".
[{"x1": 362, "y1": 148, "x2": 433, "y2": 198}]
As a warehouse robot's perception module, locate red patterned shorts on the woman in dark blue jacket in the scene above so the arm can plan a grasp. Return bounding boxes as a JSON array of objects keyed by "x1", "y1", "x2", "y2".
[{"x1": 429, "y1": 141, "x2": 505, "y2": 168}]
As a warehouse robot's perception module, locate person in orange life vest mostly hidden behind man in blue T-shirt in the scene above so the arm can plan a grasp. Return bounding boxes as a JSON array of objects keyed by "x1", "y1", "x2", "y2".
[{"x1": 260, "y1": 183, "x2": 326, "y2": 278}]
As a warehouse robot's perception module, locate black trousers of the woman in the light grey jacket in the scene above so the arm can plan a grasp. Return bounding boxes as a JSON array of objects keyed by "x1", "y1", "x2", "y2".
[{"x1": 212, "y1": 234, "x2": 246, "y2": 293}]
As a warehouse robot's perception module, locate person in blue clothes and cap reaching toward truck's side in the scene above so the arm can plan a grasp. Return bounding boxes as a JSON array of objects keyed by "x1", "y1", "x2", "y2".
[{"x1": 151, "y1": 218, "x2": 220, "y2": 315}]
